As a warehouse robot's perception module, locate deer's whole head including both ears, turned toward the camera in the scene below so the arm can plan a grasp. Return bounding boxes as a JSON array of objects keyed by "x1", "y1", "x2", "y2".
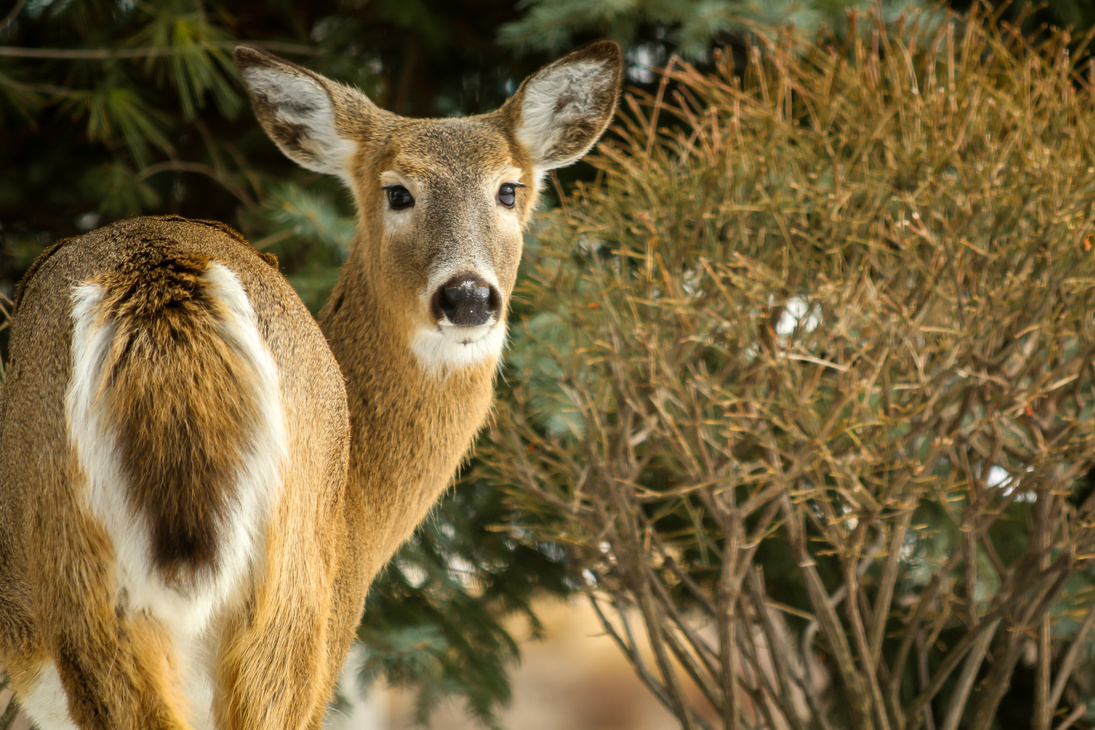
[{"x1": 237, "y1": 43, "x2": 621, "y2": 372}]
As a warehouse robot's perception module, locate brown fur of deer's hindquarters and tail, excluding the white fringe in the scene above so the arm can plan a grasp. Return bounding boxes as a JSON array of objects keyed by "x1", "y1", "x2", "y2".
[{"x1": 0, "y1": 217, "x2": 348, "y2": 730}]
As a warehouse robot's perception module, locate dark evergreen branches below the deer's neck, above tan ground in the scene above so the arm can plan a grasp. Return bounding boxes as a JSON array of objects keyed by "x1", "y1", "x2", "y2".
[{"x1": 358, "y1": 480, "x2": 573, "y2": 725}]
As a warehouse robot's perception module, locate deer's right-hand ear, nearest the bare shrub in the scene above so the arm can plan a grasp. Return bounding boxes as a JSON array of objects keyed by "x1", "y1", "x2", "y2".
[{"x1": 504, "y1": 40, "x2": 623, "y2": 173}]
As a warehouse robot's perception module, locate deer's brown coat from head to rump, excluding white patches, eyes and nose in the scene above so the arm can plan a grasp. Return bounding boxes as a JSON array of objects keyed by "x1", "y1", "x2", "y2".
[{"x1": 0, "y1": 44, "x2": 621, "y2": 730}]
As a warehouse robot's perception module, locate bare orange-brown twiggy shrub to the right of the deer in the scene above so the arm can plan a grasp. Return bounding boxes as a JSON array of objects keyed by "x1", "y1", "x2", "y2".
[{"x1": 476, "y1": 9, "x2": 1095, "y2": 730}]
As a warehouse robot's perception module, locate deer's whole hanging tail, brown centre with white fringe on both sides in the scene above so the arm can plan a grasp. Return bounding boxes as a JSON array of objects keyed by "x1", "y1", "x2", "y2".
[{"x1": 68, "y1": 246, "x2": 284, "y2": 584}]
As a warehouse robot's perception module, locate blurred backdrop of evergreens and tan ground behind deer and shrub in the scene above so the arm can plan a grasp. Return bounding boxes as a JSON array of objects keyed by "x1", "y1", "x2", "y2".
[{"x1": 6, "y1": 0, "x2": 1095, "y2": 730}]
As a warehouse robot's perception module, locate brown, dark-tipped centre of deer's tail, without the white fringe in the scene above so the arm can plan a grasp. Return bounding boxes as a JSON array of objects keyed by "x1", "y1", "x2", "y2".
[{"x1": 90, "y1": 248, "x2": 258, "y2": 584}]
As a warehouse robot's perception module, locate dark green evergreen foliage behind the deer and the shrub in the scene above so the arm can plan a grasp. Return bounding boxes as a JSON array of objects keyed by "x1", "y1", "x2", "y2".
[{"x1": 6, "y1": 0, "x2": 1093, "y2": 723}]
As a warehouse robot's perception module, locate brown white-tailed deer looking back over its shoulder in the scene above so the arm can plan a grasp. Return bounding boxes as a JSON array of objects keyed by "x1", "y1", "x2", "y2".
[{"x1": 0, "y1": 42, "x2": 622, "y2": 730}]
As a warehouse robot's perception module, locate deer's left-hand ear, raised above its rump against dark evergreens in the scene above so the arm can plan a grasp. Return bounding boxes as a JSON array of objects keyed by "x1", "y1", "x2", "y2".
[{"x1": 235, "y1": 46, "x2": 374, "y2": 184}]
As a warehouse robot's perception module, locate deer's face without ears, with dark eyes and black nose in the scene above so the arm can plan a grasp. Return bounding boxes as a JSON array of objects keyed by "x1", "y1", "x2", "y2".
[{"x1": 363, "y1": 117, "x2": 525, "y2": 368}]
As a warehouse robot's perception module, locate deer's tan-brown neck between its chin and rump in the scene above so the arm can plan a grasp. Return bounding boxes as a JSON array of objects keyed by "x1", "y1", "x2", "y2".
[{"x1": 320, "y1": 256, "x2": 497, "y2": 580}]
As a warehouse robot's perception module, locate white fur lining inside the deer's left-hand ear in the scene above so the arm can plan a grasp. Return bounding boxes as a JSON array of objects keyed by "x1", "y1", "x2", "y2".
[{"x1": 242, "y1": 66, "x2": 357, "y2": 185}]
